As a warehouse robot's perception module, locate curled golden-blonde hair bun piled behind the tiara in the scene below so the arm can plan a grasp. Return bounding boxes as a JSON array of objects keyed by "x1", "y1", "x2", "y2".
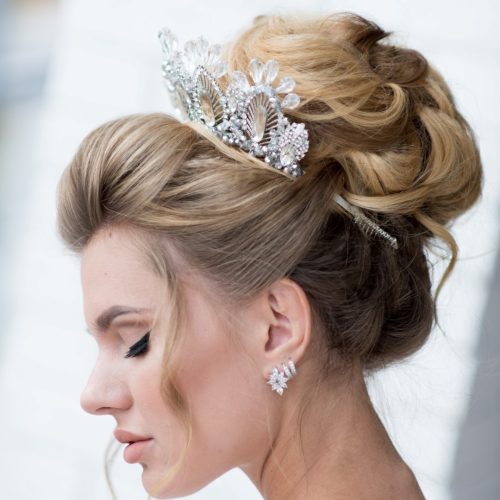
[{"x1": 228, "y1": 12, "x2": 483, "y2": 294}]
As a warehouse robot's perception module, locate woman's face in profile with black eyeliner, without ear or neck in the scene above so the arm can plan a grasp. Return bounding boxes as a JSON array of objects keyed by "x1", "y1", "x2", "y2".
[{"x1": 81, "y1": 227, "x2": 271, "y2": 498}]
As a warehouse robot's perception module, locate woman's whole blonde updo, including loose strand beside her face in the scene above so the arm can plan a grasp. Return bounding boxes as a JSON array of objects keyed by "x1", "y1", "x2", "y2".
[{"x1": 58, "y1": 12, "x2": 483, "y2": 498}]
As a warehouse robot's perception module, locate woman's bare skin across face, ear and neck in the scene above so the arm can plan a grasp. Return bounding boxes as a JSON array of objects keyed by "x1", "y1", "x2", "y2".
[{"x1": 81, "y1": 226, "x2": 424, "y2": 500}]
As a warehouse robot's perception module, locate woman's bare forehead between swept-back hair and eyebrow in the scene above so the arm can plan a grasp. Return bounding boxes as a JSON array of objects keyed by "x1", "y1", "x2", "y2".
[{"x1": 80, "y1": 227, "x2": 162, "y2": 322}]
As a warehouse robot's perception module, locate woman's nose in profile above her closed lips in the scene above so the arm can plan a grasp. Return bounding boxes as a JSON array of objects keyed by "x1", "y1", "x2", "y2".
[{"x1": 80, "y1": 360, "x2": 131, "y2": 415}]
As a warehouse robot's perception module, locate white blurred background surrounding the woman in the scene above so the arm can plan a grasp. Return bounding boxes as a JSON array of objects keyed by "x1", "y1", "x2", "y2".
[{"x1": 0, "y1": 0, "x2": 500, "y2": 500}]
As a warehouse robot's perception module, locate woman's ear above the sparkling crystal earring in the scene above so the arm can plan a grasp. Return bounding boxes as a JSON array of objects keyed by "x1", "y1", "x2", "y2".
[{"x1": 258, "y1": 278, "x2": 311, "y2": 378}]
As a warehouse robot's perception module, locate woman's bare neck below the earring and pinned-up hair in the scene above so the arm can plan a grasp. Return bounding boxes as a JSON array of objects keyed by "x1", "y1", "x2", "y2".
[{"x1": 243, "y1": 360, "x2": 424, "y2": 500}]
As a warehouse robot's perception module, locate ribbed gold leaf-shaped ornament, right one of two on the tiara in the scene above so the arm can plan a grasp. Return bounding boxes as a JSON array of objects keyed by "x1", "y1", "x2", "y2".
[{"x1": 244, "y1": 92, "x2": 279, "y2": 146}]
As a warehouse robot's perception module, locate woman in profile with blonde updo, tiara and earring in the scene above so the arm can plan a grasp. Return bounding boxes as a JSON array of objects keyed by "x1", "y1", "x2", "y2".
[{"x1": 58, "y1": 13, "x2": 482, "y2": 500}]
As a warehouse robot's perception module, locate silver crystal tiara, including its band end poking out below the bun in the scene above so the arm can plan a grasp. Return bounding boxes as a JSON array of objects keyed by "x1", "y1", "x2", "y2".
[{"x1": 158, "y1": 28, "x2": 398, "y2": 248}]
